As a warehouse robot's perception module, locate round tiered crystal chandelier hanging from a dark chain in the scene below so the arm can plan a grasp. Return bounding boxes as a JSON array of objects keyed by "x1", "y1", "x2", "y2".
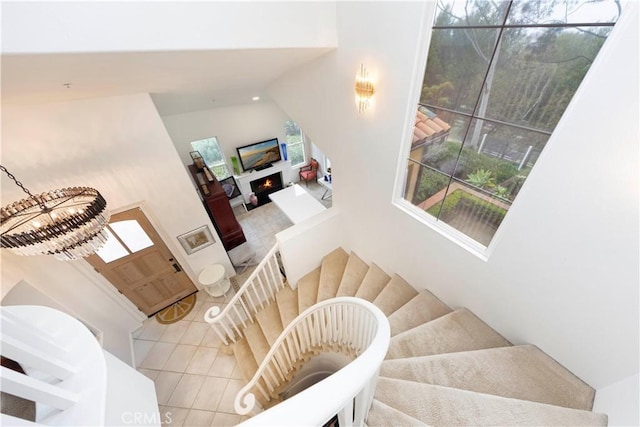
[{"x1": 0, "y1": 165, "x2": 111, "y2": 261}]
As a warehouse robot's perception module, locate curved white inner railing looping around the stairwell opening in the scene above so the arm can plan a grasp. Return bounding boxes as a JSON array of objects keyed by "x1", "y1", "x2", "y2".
[{"x1": 235, "y1": 297, "x2": 391, "y2": 426}]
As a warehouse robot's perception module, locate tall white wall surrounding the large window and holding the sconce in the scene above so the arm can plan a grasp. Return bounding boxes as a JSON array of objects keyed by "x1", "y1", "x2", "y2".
[{"x1": 270, "y1": 2, "x2": 639, "y2": 422}]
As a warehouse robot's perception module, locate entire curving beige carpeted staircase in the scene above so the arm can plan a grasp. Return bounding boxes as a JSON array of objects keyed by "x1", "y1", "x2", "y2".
[{"x1": 232, "y1": 248, "x2": 607, "y2": 426}]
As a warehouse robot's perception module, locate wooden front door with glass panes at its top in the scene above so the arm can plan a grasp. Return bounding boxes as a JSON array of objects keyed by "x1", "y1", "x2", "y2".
[{"x1": 85, "y1": 208, "x2": 197, "y2": 316}]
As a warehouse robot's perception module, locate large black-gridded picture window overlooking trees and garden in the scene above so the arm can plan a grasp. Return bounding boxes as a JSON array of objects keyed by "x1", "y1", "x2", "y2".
[{"x1": 404, "y1": 0, "x2": 620, "y2": 251}]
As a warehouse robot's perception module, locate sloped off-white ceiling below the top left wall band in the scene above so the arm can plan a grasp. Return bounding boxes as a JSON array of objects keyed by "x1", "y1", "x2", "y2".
[{"x1": 1, "y1": 48, "x2": 331, "y2": 116}]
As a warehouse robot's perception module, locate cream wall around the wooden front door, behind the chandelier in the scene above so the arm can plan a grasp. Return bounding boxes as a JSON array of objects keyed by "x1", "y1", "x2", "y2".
[{"x1": 2, "y1": 94, "x2": 234, "y2": 360}]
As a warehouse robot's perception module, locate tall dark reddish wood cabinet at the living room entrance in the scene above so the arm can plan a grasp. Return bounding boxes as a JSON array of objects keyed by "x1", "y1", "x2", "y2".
[{"x1": 189, "y1": 165, "x2": 247, "y2": 251}]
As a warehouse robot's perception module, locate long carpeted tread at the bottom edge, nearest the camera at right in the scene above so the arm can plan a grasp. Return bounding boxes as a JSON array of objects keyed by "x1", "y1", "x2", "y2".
[{"x1": 375, "y1": 377, "x2": 607, "y2": 426}]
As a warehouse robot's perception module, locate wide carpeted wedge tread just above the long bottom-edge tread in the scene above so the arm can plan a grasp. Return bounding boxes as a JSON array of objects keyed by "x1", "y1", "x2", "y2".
[{"x1": 380, "y1": 345, "x2": 595, "y2": 411}]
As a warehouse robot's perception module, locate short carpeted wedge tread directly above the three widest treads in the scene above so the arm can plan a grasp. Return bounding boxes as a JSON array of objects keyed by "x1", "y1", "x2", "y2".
[{"x1": 389, "y1": 289, "x2": 451, "y2": 336}]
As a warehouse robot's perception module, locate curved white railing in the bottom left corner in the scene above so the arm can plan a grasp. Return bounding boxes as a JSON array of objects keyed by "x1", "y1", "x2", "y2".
[{"x1": 0, "y1": 305, "x2": 107, "y2": 426}]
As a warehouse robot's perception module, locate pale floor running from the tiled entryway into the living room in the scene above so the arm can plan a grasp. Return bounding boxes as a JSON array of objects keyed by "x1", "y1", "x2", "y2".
[{"x1": 133, "y1": 183, "x2": 331, "y2": 426}]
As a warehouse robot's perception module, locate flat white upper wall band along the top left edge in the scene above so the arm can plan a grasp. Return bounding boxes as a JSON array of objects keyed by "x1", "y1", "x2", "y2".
[{"x1": 2, "y1": 1, "x2": 335, "y2": 54}]
